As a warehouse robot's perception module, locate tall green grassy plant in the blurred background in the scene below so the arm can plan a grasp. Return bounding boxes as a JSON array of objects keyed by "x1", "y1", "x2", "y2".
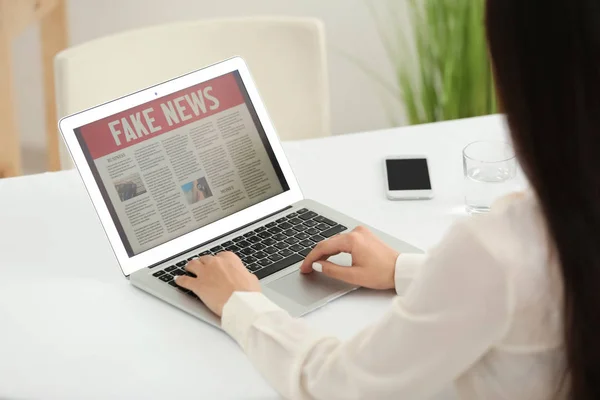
[{"x1": 363, "y1": 0, "x2": 496, "y2": 124}]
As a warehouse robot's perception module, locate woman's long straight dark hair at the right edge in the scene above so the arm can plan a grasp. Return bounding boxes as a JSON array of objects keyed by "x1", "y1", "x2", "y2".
[{"x1": 486, "y1": 0, "x2": 600, "y2": 400}]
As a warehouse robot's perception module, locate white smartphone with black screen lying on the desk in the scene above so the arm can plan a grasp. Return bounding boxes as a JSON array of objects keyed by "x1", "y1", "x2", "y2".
[{"x1": 383, "y1": 156, "x2": 433, "y2": 200}]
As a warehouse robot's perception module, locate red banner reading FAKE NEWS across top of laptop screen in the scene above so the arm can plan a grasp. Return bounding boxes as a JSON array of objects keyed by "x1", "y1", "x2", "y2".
[{"x1": 80, "y1": 73, "x2": 244, "y2": 159}]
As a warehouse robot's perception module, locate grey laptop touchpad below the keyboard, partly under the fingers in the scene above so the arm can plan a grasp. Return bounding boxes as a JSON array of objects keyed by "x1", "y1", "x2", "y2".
[{"x1": 267, "y1": 255, "x2": 353, "y2": 306}]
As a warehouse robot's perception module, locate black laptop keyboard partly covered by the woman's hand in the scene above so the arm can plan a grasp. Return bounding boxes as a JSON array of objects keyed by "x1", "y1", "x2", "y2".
[{"x1": 152, "y1": 208, "x2": 347, "y2": 297}]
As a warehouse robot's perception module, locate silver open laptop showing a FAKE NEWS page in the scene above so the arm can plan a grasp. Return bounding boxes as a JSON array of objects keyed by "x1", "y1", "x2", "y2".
[{"x1": 59, "y1": 57, "x2": 419, "y2": 327}]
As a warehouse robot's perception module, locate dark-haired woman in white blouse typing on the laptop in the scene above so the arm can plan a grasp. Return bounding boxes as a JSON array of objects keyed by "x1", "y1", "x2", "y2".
[{"x1": 177, "y1": 0, "x2": 600, "y2": 400}]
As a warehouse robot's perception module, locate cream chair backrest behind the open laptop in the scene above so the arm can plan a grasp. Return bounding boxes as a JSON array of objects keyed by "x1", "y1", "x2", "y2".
[{"x1": 55, "y1": 17, "x2": 330, "y2": 169}]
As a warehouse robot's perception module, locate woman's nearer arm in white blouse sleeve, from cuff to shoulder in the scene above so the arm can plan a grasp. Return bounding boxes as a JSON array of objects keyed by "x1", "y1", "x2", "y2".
[{"x1": 222, "y1": 225, "x2": 511, "y2": 400}]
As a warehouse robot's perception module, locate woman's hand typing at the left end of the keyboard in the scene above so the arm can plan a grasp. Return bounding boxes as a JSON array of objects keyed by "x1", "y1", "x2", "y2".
[{"x1": 175, "y1": 251, "x2": 260, "y2": 317}]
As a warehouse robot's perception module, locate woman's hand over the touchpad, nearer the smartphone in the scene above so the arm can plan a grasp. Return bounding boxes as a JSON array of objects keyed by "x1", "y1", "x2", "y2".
[{"x1": 300, "y1": 226, "x2": 400, "y2": 289}]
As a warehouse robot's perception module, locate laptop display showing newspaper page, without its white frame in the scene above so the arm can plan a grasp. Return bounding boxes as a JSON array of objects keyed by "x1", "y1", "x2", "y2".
[{"x1": 75, "y1": 71, "x2": 289, "y2": 257}]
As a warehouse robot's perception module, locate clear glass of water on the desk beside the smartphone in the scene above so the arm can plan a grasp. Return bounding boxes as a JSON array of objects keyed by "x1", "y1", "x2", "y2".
[{"x1": 463, "y1": 141, "x2": 517, "y2": 214}]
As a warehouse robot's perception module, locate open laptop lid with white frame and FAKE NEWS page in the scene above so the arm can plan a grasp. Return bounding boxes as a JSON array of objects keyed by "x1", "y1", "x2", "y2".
[{"x1": 59, "y1": 57, "x2": 302, "y2": 275}]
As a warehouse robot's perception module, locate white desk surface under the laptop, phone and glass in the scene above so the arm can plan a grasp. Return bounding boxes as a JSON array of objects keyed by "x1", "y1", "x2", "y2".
[{"x1": 0, "y1": 117, "x2": 505, "y2": 399}]
